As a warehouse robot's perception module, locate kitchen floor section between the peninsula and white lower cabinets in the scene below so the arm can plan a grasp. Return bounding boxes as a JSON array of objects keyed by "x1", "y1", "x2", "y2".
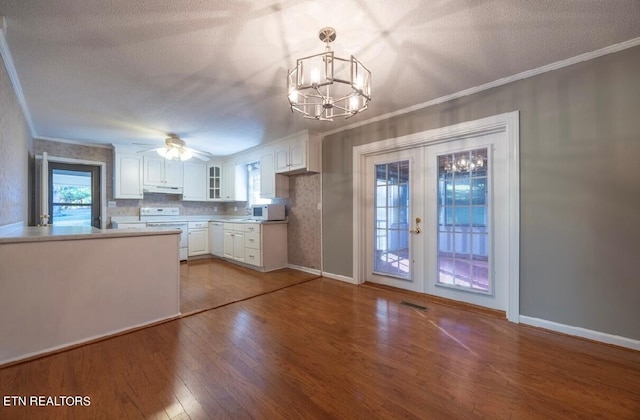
[{"x1": 180, "y1": 258, "x2": 318, "y2": 316}]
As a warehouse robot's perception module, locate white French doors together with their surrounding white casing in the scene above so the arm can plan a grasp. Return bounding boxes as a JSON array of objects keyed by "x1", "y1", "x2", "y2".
[{"x1": 354, "y1": 112, "x2": 519, "y2": 322}]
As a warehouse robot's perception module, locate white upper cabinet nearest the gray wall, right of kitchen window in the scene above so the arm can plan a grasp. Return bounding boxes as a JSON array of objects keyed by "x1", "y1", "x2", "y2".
[{"x1": 274, "y1": 130, "x2": 321, "y2": 175}]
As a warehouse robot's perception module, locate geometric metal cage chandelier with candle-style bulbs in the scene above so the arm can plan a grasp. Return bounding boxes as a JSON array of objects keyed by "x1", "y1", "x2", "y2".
[{"x1": 287, "y1": 28, "x2": 371, "y2": 121}]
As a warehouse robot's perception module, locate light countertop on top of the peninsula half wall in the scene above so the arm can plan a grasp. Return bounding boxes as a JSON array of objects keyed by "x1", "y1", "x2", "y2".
[{"x1": 0, "y1": 226, "x2": 180, "y2": 245}]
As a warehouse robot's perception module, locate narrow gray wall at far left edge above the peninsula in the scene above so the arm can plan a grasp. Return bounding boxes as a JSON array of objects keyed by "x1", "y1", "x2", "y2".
[{"x1": 0, "y1": 51, "x2": 32, "y2": 227}]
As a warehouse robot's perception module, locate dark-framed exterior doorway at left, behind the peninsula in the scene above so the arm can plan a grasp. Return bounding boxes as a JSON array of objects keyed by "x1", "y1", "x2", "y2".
[{"x1": 47, "y1": 162, "x2": 102, "y2": 228}]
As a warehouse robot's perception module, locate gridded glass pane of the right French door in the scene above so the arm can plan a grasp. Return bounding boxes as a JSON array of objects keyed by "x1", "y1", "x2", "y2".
[{"x1": 437, "y1": 148, "x2": 491, "y2": 293}]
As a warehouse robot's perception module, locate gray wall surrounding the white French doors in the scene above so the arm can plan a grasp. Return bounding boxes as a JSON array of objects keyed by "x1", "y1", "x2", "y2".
[{"x1": 322, "y1": 47, "x2": 640, "y2": 339}]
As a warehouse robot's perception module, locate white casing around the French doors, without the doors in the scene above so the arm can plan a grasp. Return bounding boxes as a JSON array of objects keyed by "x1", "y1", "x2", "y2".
[{"x1": 353, "y1": 111, "x2": 520, "y2": 323}]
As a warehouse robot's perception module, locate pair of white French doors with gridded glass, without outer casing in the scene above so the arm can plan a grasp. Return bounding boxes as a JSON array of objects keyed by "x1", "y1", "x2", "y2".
[{"x1": 365, "y1": 133, "x2": 509, "y2": 310}]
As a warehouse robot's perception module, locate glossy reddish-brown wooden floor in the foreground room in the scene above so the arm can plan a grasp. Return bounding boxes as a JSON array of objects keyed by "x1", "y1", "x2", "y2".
[{"x1": 0, "y1": 276, "x2": 640, "y2": 419}]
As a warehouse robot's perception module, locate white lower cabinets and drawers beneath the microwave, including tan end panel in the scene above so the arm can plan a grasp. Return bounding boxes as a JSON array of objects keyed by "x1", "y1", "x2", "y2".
[{"x1": 224, "y1": 223, "x2": 288, "y2": 271}]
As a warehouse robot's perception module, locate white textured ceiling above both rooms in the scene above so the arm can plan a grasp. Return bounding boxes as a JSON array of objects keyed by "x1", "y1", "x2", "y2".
[{"x1": 0, "y1": 0, "x2": 640, "y2": 155}]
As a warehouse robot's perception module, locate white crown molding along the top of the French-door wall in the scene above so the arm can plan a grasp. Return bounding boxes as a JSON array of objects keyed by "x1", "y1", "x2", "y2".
[{"x1": 322, "y1": 38, "x2": 640, "y2": 136}]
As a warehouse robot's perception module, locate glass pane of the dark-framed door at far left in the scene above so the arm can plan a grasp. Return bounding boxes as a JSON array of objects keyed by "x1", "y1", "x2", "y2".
[{"x1": 51, "y1": 169, "x2": 92, "y2": 226}]
